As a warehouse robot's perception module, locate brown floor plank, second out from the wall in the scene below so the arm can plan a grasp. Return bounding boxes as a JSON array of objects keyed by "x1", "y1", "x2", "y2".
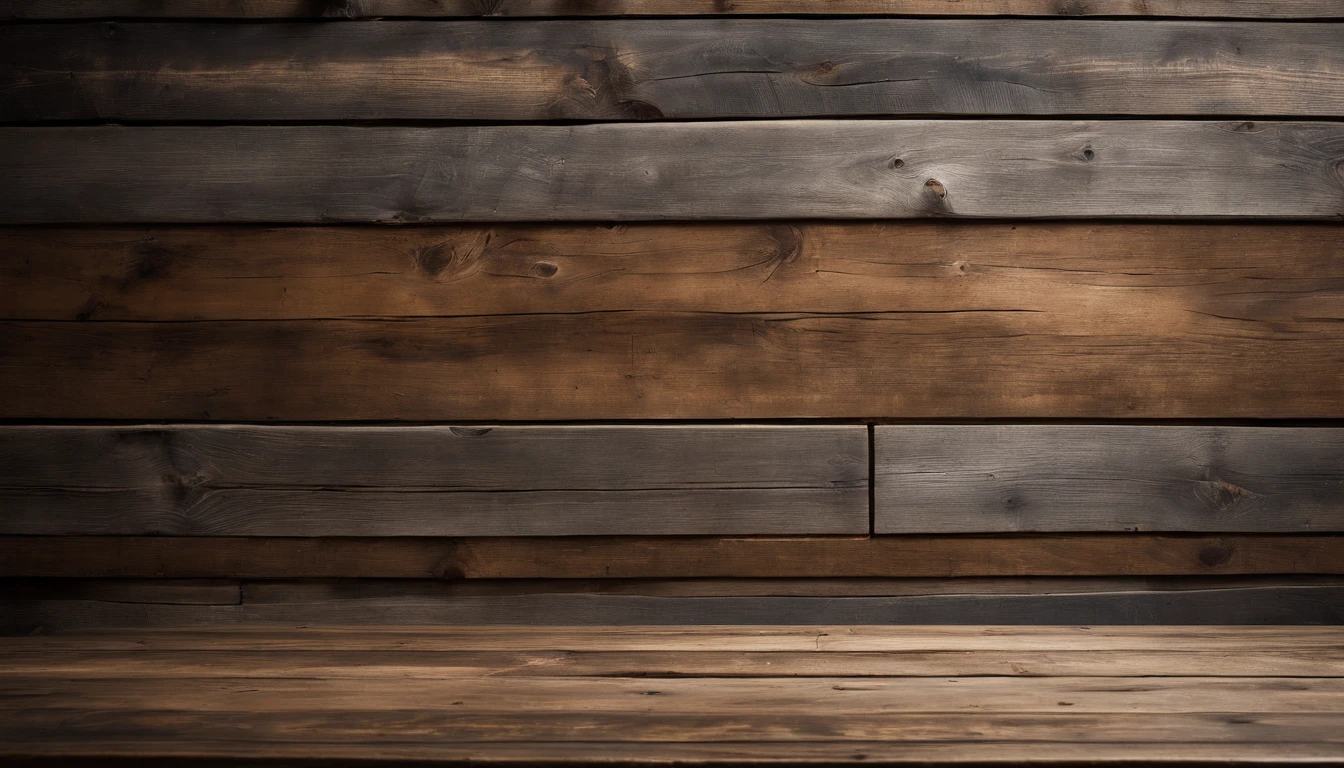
[{"x1": 0, "y1": 647, "x2": 1344, "y2": 679}]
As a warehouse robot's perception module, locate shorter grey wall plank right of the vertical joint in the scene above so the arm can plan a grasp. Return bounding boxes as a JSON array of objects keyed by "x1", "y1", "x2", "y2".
[{"x1": 874, "y1": 425, "x2": 1344, "y2": 533}]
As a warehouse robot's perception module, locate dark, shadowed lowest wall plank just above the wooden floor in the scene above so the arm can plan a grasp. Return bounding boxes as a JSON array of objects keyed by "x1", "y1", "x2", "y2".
[{"x1": 0, "y1": 576, "x2": 1344, "y2": 635}]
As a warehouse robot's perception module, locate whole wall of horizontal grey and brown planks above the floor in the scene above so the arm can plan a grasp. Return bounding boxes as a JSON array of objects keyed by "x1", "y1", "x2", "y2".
[{"x1": 0, "y1": 0, "x2": 1344, "y2": 632}]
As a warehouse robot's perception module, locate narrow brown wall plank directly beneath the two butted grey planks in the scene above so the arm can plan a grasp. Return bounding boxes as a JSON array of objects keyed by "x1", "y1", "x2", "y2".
[{"x1": 0, "y1": 534, "x2": 1344, "y2": 575}]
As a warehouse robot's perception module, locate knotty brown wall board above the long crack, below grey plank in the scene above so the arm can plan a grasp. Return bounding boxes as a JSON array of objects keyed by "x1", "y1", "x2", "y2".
[{"x1": 10, "y1": 221, "x2": 1344, "y2": 325}]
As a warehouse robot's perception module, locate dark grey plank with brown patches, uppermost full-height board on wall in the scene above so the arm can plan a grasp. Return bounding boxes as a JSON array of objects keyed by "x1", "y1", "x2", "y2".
[{"x1": 0, "y1": 19, "x2": 1344, "y2": 122}]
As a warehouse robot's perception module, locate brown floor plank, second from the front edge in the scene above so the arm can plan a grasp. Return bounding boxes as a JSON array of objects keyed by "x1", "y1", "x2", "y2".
[{"x1": 0, "y1": 710, "x2": 1344, "y2": 744}]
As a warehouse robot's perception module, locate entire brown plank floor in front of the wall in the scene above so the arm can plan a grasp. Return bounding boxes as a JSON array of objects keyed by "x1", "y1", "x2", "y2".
[{"x1": 0, "y1": 627, "x2": 1344, "y2": 765}]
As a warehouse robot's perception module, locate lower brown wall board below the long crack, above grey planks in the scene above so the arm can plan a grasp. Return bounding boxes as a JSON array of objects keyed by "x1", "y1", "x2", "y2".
[{"x1": 10, "y1": 316, "x2": 1344, "y2": 421}]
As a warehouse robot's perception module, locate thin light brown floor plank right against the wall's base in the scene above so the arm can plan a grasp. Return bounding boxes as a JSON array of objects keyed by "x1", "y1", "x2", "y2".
[{"x1": 13, "y1": 624, "x2": 1340, "y2": 650}]
